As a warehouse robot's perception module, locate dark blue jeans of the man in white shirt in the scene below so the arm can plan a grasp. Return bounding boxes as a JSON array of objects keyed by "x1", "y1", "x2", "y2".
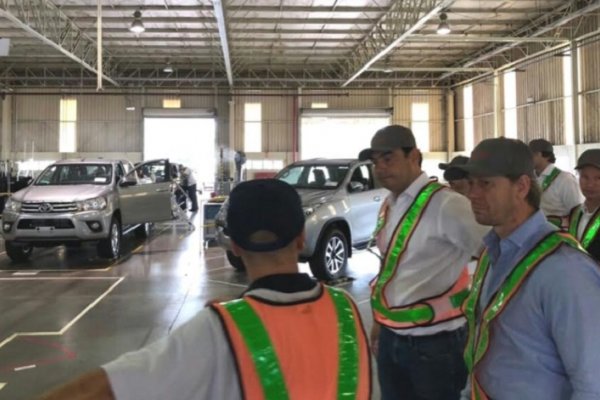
[{"x1": 377, "y1": 327, "x2": 467, "y2": 400}]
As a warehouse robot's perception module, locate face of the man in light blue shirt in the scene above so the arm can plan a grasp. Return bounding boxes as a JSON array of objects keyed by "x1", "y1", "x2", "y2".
[{"x1": 468, "y1": 176, "x2": 519, "y2": 226}]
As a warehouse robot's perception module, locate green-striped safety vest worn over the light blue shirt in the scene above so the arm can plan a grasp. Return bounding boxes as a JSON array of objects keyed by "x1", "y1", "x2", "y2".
[{"x1": 463, "y1": 232, "x2": 584, "y2": 400}]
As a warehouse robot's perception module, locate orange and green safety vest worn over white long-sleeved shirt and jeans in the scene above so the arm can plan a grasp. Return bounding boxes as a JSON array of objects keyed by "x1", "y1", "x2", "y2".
[{"x1": 371, "y1": 182, "x2": 469, "y2": 329}]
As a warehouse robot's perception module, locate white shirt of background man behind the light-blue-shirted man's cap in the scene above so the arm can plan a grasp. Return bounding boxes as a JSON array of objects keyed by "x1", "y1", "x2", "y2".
[{"x1": 537, "y1": 164, "x2": 583, "y2": 217}]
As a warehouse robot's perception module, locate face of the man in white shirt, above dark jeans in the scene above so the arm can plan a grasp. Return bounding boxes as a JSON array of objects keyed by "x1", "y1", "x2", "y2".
[{"x1": 373, "y1": 149, "x2": 419, "y2": 195}]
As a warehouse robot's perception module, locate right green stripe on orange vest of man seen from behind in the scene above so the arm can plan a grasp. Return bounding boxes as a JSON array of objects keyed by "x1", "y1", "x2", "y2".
[{"x1": 327, "y1": 287, "x2": 360, "y2": 399}]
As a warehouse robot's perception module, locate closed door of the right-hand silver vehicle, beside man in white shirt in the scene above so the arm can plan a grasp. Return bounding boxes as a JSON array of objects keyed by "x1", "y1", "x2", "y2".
[{"x1": 346, "y1": 164, "x2": 387, "y2": 244}]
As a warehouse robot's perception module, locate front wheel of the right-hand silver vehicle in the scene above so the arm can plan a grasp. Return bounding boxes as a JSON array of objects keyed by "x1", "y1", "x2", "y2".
[{"x1": 308, "y1": 228, "x2": 348, "y2": 281}]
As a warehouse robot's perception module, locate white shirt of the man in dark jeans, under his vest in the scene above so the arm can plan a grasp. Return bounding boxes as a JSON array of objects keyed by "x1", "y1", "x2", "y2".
[{"x1": 377, "y1": 173, "x2": 490, "y2": 335}]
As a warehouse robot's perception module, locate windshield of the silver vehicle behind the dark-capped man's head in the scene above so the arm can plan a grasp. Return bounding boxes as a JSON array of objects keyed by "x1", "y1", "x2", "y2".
[{"x1": 277, "y1": 164, "x2": 350, "y2": 189}]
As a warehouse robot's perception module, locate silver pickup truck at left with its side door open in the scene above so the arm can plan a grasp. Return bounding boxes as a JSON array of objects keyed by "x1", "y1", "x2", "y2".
[{"x1": 2, "y1": 159, "x2": 173, "y2": 261}]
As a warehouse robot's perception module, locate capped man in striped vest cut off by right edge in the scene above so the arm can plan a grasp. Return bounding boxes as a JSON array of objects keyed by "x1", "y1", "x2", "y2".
[{"x1": 566, "y1": 149, "x2": 600, "y2": 261}]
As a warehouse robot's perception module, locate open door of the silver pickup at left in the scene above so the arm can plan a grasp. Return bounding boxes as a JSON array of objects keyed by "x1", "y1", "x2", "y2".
[{"x1": 118, "y1": 159, "x2": 173, "y2": 225}]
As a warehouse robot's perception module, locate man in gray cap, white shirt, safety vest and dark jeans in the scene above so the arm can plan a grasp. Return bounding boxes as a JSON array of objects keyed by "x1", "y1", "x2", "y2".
[{"x1": 359, "y1": 125, "x2": 489, "y2": 400}]
